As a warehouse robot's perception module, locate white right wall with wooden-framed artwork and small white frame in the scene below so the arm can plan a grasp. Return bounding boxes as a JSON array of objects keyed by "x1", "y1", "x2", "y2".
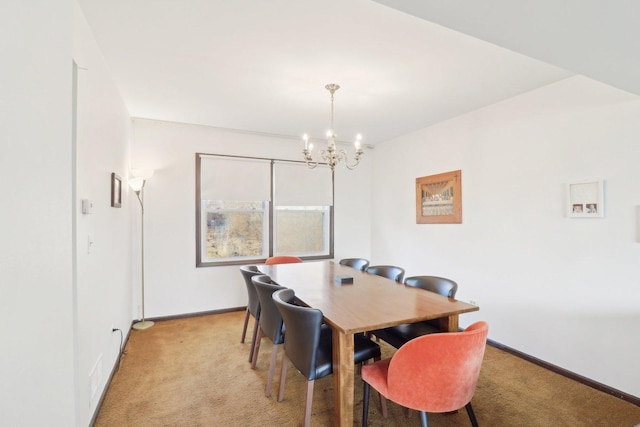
[{"x1": 371, "y1": 77, "x2": 640, "y2": 396}]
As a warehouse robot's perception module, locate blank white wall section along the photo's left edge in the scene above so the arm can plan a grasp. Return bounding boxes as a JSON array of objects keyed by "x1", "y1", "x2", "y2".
[{"x1": 0, "y1": 0, "x2": 76, "y2": 426}]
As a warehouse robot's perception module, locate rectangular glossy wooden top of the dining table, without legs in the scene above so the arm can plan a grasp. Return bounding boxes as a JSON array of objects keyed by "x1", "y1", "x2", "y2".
[{"x1": 260, "y1": 261, "x2": 478, "y2": 334}]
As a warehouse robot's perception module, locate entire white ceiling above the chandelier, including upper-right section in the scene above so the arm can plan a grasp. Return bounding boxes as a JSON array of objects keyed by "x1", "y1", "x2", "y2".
[{"x1": 78, "y1": 0, "x2": 640, "y2": 145}]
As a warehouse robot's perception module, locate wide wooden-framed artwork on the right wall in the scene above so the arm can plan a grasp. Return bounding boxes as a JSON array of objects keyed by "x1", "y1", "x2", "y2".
[{"x1": 416, "y1": 170, "x2": 462, "y2": 224}]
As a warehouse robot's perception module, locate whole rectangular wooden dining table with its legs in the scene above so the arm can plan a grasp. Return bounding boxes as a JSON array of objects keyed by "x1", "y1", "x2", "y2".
[{"x1": 260, "y1": 261, "x2": 479, "y2": 427}]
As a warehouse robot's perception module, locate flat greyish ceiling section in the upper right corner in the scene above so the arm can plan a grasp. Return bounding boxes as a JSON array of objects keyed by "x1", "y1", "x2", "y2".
[{"x1": 375, "y1": 0, "x2": 640, "y2": 95}]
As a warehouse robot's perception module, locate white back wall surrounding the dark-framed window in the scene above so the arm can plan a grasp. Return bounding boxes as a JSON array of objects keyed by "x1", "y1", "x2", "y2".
[{"x1": 132, "y1": 119, "x2": 372, "y2": 317}]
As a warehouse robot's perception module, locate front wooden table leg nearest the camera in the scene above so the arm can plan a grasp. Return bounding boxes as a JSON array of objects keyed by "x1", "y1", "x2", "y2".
[{"x1": 333, "y1": 329, "x2": 354, "y2": 427}]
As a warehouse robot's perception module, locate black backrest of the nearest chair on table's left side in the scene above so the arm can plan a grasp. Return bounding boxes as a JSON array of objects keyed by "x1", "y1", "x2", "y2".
[{"x1": 273, "y1": 289, "x2": 323, "y2": 380}]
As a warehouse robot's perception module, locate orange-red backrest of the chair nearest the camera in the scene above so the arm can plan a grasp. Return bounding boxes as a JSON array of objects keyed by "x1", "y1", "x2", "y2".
[{"x1": 387, "y1": 321, "x2": 489, "y2": 412}]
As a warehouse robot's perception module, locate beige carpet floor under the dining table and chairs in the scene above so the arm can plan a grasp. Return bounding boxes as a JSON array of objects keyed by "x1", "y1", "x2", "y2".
[{"x1": 95, "y1": 312, "x2": 640, "y2": 427}]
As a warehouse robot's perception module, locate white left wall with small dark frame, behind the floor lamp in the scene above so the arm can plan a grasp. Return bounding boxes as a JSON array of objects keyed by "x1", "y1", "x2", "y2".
[{"x1": 73, "y1": 5, "x2": 133, "y2": 425}]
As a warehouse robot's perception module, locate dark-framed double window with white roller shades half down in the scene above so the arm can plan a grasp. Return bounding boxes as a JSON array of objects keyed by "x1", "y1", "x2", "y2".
[{"x1": 196, "y1": 153, "x2": 333, "y2": 267}]
